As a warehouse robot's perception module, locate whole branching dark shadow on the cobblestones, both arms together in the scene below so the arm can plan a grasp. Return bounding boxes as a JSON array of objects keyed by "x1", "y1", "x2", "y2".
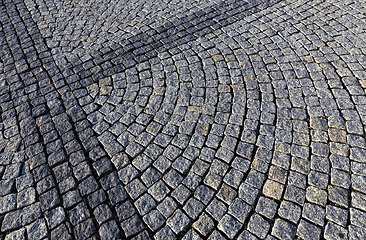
[{"x1": 0, "y1": 0, "x2": 280, "y2": 237}]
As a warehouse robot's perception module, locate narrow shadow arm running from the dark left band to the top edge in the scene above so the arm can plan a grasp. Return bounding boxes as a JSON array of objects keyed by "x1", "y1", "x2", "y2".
[{"x1": 87, "y1": 0, "x2": 281, "y2": 67}]
